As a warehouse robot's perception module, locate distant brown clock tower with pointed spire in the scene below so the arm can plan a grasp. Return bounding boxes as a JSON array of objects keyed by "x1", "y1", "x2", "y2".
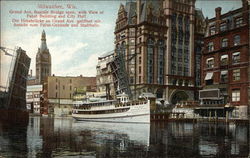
[{"x1": 36, "y1": 30, "x2": 51, "y2": 84}]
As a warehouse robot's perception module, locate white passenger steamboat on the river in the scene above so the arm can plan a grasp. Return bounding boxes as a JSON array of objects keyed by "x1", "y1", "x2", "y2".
[{"x1": 72, "y1": 93, "x2": 150, "y2": 123}]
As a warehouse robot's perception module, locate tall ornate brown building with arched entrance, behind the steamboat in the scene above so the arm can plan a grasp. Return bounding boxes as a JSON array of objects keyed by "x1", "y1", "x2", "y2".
[{"x1": 115, "y1": 0, "x2": 204, "y2": 104}]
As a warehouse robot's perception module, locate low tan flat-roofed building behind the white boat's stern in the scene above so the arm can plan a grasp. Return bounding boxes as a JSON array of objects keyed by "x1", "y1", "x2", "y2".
[{"x1": 42, "y1": 75, "x2": 96, "y2": 116}]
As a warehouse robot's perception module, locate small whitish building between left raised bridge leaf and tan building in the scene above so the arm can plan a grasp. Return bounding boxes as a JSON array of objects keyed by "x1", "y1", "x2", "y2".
[{"x1": 26, "y1": 85, "x2": 43, "y2": 115}]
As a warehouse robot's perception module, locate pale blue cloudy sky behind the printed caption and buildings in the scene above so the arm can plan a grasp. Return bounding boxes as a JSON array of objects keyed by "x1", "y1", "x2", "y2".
[{"x1": 0, "y1": 0, "x2": 242, "y2": 87}]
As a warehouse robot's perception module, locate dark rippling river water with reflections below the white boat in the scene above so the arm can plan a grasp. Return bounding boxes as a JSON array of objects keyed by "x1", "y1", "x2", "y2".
[{"x1": 0, "y1": 117, "x2": 250, "y2": 158}]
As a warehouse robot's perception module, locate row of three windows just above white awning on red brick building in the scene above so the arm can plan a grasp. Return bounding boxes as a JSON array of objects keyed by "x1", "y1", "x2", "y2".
[{"x1": 206, "y1": 52, "x2": 240, "y2": 68}]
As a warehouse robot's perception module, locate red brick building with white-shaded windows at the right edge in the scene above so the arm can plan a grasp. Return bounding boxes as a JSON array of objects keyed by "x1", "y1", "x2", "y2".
[{"x1": 202, "y1": 0, "x2": 250, "y2": 117}]
